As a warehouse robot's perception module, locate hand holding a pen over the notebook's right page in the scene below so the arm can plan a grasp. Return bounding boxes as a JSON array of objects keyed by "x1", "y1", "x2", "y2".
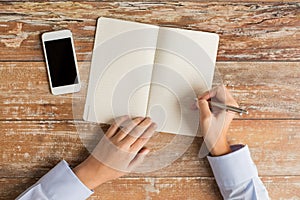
[{"x1": 198, "y1": 86, "x2": 238, "y2": 156}]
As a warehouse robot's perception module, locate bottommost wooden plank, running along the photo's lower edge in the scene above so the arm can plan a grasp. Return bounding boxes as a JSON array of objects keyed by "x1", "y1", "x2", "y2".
[{"x1": 0, "y1": 176, "x2": 300, "y2": 200}]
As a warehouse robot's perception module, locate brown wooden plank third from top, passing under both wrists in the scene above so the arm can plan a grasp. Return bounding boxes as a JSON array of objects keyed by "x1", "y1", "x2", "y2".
[{"x1": 0, "y1": 120, "x2": 300, "y2": 177}]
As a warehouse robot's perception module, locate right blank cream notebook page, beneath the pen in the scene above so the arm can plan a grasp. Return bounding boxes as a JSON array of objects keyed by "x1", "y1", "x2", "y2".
[{"x1": 147, "y1": 28, "x2": 219, "y2": 136}]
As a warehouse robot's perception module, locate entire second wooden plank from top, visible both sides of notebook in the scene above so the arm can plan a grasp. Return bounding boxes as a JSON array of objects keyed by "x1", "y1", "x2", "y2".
[{"x1": 0, "y1": 62, "x2": 300, "y2": 120}]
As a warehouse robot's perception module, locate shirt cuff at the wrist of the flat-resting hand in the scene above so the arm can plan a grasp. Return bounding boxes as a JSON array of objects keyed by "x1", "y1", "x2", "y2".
[{"x1": 38, "y1": 160, "x2": 93, "y2": 200}]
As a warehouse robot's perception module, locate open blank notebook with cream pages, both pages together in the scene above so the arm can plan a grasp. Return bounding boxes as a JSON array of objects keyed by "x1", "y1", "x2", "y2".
[{"x1": 83, "y1": 17, "x2": 219, "y2": 136}]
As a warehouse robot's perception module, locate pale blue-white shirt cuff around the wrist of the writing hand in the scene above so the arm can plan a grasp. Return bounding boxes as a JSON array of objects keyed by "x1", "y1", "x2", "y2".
[{"x1": 207, "y1": 145, "x2": 258, "y2": 187}]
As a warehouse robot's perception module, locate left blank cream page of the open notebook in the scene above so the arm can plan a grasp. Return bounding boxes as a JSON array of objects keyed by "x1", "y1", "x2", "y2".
[{"x1": 84, "y1": 18, "x2": 158, "y2": 123}]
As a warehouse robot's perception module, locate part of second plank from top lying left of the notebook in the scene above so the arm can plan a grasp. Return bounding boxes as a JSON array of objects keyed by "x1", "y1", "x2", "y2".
[{"x1": 0, "y1": 62, "x2": 90, "y2": 120}]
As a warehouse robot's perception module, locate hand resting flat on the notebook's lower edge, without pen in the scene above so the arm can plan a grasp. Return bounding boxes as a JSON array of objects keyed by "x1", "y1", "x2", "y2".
[{"x1": 74, "y1": 116, "x2": 157, "y2": 189}]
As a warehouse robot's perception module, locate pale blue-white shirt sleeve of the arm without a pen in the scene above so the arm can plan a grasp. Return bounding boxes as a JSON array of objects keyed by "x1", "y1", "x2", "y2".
[{"x1": 17, "y1": 160, "x2": 93, "y2": 200}]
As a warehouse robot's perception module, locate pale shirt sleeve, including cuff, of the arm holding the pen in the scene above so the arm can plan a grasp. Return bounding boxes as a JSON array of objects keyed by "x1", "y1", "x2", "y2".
[{"x1": 207, "y1": 145, "x2": 269, "y2": 200}]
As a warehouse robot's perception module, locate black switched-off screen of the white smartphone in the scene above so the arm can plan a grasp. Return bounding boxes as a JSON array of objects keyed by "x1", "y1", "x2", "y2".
[{"x1": 45, "y1": 38, "x2": 78, "y2": 87}]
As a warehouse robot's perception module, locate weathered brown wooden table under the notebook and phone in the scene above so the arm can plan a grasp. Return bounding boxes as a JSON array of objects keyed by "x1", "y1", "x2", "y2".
[{"x1": 0, "y1": 0, "x2": 300, "y2": 200}]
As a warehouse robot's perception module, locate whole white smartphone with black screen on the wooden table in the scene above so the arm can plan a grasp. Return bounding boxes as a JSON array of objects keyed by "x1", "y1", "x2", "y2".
[{"x1": 42, "y1": 30, "x2": 80, "y2": 95}]
